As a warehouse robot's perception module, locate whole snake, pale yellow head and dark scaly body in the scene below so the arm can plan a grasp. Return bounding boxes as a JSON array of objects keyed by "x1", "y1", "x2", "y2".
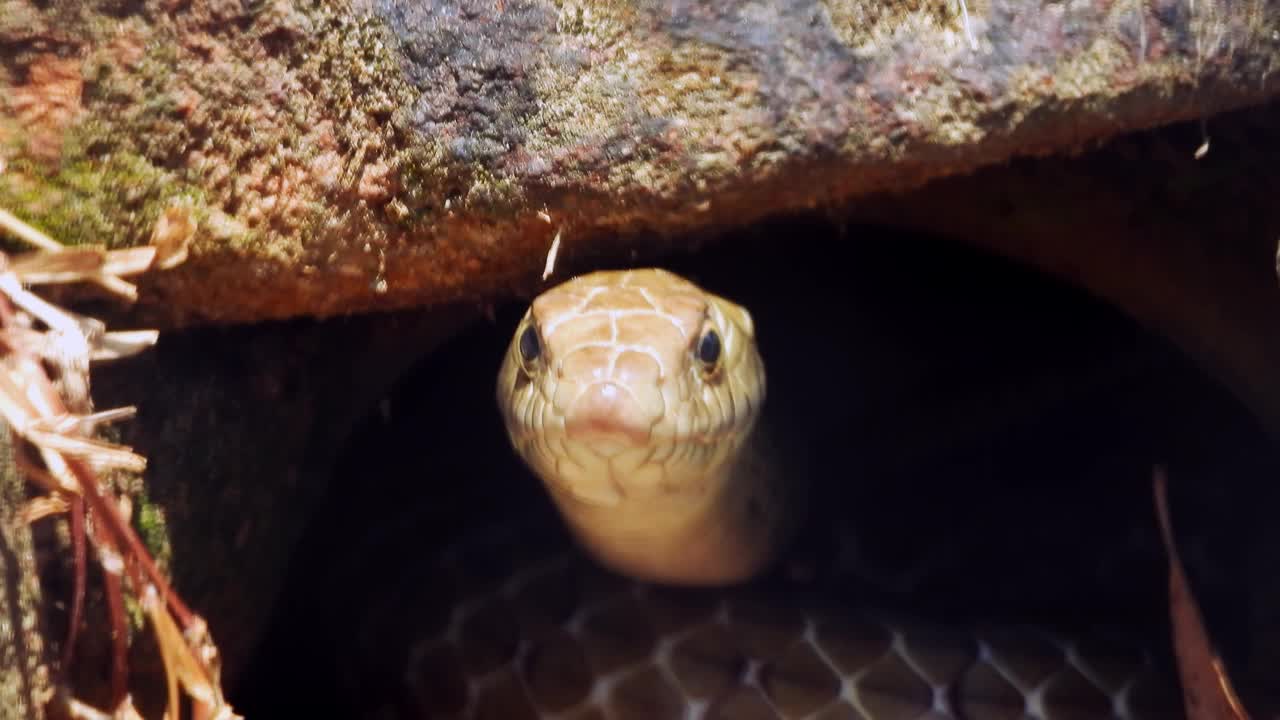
[{"x1": 350, "y1": 268, "x2": 1184, "y2": 720}]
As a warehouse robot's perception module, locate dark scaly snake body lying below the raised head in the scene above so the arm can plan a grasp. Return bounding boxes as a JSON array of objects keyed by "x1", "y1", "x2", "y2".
[{"x1": 386, "y1": 515, "x2": 1184, "y2": 720}]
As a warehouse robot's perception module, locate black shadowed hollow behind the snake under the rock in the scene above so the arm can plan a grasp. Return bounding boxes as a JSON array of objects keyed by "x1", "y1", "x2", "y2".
[{"x1": 233, "y1": 217, "x2": 1276, "y2": 717}]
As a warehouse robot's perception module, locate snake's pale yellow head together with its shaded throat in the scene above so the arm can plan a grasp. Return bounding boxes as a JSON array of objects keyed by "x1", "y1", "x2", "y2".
[{"x1": 498, "y1": 269, "x2": 794, "y2": 584}]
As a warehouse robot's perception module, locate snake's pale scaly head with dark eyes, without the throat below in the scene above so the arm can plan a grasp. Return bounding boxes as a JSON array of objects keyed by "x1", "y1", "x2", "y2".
[{"x1": 498, "y1": 269, "x2": 765, "y2": 506}]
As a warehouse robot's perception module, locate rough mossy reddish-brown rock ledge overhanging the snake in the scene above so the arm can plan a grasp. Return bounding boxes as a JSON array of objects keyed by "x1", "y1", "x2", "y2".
[{"x1": 0, "y1": 0, "x2": 1280, "y2": 323}]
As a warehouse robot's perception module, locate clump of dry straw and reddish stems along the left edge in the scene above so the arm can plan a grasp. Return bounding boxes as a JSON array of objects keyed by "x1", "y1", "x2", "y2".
[{"x1": 0, "y1": 206, "x2": 239, "y2": 720}]
